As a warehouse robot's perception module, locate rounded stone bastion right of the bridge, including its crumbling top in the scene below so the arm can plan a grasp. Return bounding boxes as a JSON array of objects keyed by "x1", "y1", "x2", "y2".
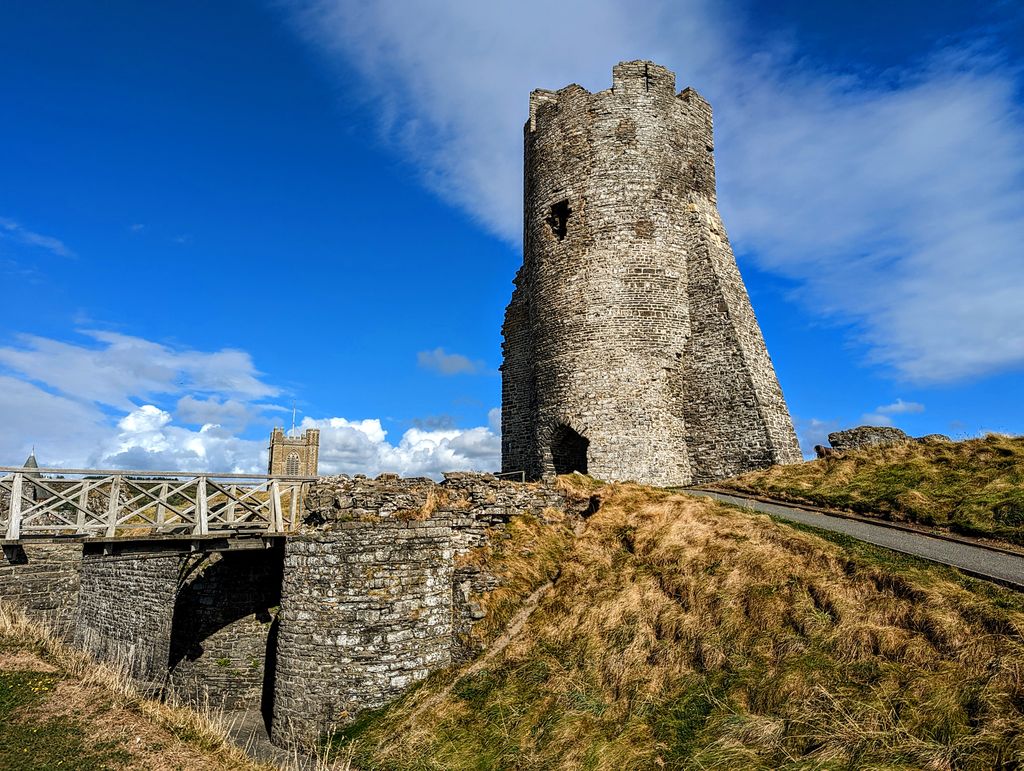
[{"x1": 272, "y1": 473, "x2": 588, "y2": 742}]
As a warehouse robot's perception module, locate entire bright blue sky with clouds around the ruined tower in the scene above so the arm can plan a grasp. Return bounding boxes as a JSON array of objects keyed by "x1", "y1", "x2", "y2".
[{"x1": 0, "y1": 0, "x2": 1024, "y2": 474}]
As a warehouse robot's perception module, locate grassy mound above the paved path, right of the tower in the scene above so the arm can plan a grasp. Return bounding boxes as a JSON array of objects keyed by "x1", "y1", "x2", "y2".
[{"x1": 718, "y1": 434, "x2": 1024, "y2": 545}]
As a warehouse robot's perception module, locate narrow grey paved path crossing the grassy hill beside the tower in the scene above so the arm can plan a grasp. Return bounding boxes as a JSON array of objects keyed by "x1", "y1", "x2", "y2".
[{"x1": 685, "y1": 489, "x2": 1024, "y2": 591}]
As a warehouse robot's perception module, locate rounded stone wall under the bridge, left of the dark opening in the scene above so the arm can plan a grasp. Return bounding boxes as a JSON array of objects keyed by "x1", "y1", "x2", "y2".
[{"x1": 75, "y1": 544, "x2": 182, "y2": 689}]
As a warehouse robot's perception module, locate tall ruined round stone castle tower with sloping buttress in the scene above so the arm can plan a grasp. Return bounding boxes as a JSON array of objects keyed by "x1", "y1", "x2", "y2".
[{"x1": 502, "y1": 61, "x2": 801, "y2": 485}]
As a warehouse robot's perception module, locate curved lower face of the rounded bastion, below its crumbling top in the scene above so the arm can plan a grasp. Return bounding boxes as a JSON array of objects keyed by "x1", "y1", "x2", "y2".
[{"x1": 271, "y1": 516, "x2": 452, "y2": 744}]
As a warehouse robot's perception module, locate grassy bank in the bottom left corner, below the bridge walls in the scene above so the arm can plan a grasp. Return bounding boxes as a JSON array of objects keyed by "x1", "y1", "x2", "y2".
[{"x1": 0, "y1": 604, "x2": 269, "y2": 771}]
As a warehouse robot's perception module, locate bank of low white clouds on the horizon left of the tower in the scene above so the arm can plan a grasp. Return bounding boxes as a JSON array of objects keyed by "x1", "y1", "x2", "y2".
[{"x1": 0, "y1": 332, "x2": 501, "y2": 477}]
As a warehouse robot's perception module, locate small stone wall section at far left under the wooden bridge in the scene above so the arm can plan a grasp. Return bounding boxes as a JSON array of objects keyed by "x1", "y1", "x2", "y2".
[{"x1": 0, "y1": 543, "x2": 82, "y2": 638}]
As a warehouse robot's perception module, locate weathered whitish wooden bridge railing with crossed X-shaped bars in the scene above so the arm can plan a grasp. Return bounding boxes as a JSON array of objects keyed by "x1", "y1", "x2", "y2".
[{"x1": 0, "y1": 466, "x2": 315, "y2": 541}]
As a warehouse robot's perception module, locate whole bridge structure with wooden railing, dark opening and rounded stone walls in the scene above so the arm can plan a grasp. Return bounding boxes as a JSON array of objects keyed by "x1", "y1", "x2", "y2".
[{"x1": 0, "y1": 468, "x2": 587, "y2": 744}]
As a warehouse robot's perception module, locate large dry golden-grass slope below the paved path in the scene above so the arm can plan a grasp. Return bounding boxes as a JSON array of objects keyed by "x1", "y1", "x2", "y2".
[{"x1": 335, "y1": 485, "x2": 1024, "y2": 770}]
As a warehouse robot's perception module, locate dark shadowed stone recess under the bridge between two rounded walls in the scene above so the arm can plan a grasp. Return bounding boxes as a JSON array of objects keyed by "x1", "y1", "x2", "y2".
[{"x1": 169, "y1": 544, "x2": 284, "y2": 710}]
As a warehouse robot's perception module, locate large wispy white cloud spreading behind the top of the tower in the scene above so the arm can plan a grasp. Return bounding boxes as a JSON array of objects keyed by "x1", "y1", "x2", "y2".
[{"x1": 287, "y1": 0, "x2": 1024, "y2": 382}]
